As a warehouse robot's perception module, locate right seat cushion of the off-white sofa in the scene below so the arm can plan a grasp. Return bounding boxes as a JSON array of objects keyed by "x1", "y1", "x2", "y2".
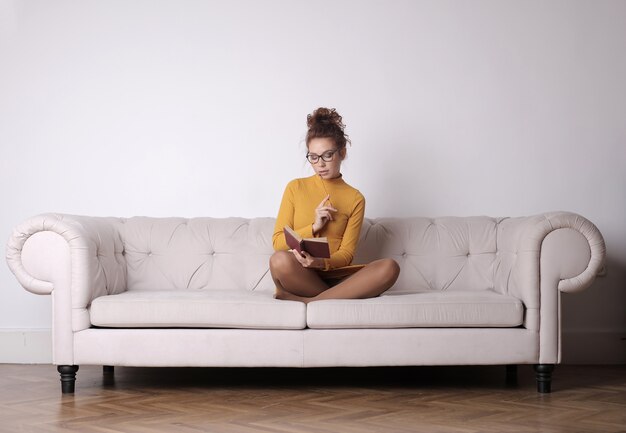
[{"x1": 307, "y1": 290, "x2": 524, "y2": 328}]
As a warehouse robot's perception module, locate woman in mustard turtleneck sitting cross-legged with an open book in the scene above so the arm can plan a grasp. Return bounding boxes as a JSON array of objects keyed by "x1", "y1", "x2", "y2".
[{"x1": 270, "y1": 108, "x2": 400, "y2": 303}]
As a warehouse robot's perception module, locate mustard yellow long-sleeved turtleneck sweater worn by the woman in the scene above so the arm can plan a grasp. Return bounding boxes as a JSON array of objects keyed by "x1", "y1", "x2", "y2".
[{"x1": 272, "y1": 174, "x2": 365, "y2": 272}]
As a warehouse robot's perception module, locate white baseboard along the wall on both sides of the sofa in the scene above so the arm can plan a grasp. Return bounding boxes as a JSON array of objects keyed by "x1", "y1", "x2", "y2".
[{"x1": 0, "y1": 329, "x2": 626, "y2": 364}]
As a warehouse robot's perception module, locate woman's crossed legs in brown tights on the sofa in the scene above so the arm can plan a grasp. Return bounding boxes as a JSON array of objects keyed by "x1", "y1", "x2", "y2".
[{"x1": 270, "y1": 251, "x2": 400, "y2": 303}]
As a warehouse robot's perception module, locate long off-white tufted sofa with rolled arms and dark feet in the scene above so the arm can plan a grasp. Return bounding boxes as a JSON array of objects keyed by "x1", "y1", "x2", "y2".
[{"x1": 7, "y1": 212, "x2": 605, "y2": 393}]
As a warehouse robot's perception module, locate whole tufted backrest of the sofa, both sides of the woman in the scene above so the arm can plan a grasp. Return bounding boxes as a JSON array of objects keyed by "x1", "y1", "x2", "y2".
[{"x1": 119, "y1": 216, "x2": 502, "y2": 293}]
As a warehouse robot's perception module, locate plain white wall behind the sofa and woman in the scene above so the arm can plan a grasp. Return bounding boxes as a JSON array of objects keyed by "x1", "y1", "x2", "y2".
[{"x1": 0, "y1": 0, "x2": 626, "y2": 362}]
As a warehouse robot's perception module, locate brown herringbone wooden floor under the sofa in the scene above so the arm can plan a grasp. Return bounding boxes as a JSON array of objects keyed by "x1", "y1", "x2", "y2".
[{"x1": 0, "y1": 364, "x2": 626, "y2": 433}]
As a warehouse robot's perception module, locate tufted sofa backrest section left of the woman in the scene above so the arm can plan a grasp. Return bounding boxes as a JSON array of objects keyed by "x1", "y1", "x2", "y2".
[{"x1": 120, "y1": 217, "x2": 274, "y2": 290}]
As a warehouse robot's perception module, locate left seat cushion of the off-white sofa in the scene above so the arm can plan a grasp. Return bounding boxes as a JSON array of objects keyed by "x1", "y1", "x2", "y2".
[{"x1": 90, "y1": 290, "x2": 306, "y2": 329}]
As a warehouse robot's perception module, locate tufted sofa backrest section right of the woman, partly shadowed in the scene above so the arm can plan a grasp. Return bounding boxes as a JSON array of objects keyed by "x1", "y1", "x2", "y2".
[{"x1": 354, "y1": 216, "x2": 504, "y2": 293}]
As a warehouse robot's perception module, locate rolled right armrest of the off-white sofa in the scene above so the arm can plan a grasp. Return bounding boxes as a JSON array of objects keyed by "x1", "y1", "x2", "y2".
[{"x1": 495, "y1": 212, "x2": 606, "y2": 363}]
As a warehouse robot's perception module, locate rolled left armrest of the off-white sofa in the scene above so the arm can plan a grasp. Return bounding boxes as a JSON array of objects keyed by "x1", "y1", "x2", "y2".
[{"x1": 6, "y1": 213, "x2": 126, "y2": 362}]
